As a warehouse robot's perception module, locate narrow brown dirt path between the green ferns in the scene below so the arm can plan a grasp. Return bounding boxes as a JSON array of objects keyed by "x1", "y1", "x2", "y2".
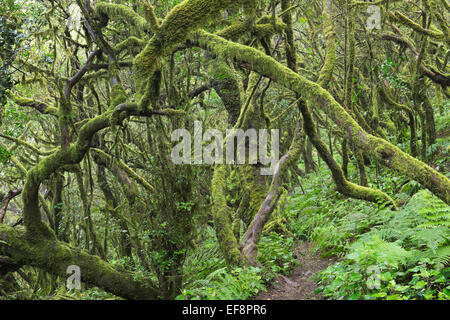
[{"x1": 254, "y1": 242, "x2": 336, "y2": 300}]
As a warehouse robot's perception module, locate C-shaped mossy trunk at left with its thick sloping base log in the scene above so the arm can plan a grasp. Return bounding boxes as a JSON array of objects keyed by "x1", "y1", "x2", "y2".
[{"x1": 13, "y1": 66, "x2": 180, "y2": 299}]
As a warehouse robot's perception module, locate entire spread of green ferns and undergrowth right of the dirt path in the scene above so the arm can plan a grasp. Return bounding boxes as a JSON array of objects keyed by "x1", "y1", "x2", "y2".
[{"x1": 285, "y1": 168, "x2": 450, "y2": 300}]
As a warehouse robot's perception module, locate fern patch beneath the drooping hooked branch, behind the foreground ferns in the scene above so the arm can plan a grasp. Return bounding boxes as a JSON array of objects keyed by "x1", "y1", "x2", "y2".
[{"x1": 286, "y1": 169, "x2": 390, "y2": 255}]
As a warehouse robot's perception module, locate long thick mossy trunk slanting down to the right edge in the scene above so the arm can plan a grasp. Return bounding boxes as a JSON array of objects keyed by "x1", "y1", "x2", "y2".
[{"x1": 196, "y1": 31, "x2": 450, "y2": 203}]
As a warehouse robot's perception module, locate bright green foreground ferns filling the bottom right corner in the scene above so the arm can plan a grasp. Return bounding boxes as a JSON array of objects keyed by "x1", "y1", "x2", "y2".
[{"x1": 317, "y1": 190, "x2": 450, "y2": 299}]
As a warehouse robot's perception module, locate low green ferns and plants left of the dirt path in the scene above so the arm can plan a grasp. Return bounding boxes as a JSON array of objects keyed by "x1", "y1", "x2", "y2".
[{"x1": 177, "y1": 227, "x2": 297, "y2": 300}]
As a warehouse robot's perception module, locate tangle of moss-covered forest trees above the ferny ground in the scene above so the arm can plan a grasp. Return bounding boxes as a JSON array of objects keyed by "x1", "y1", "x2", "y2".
[{"x1": 0, "y1": 0, "x2": 450, "y2": 299}]
